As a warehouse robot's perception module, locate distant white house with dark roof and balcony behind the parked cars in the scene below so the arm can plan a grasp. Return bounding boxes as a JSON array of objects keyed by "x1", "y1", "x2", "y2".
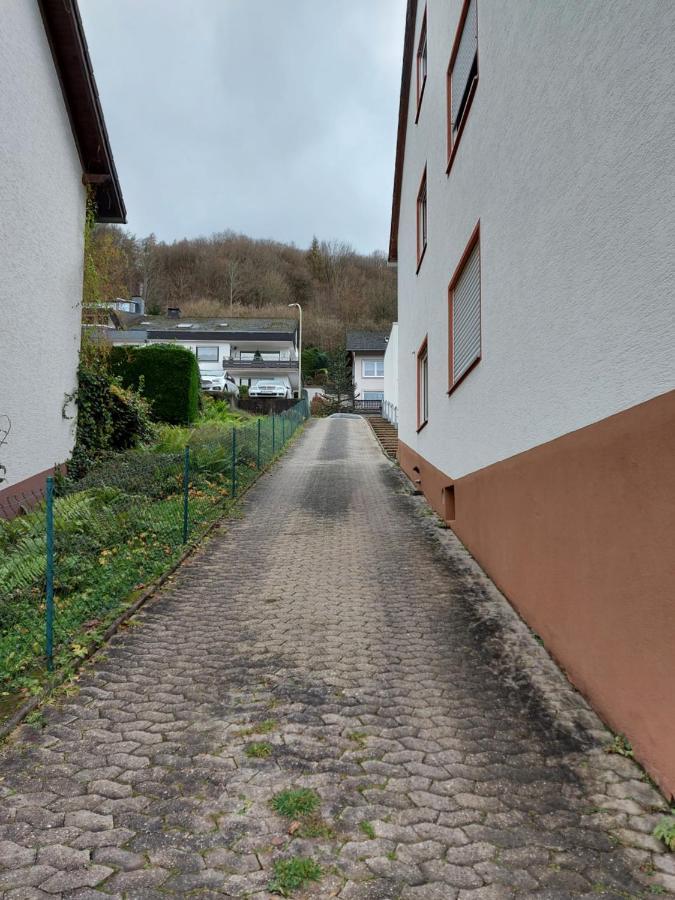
[{"x1": 101, "y1": 307, "x2": 299, "y2": 394}]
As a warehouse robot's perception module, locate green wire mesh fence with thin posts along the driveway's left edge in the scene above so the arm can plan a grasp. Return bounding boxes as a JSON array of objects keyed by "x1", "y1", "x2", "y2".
[{"x1": 0, "y1": 400, "x2": 309, "y2": 704}]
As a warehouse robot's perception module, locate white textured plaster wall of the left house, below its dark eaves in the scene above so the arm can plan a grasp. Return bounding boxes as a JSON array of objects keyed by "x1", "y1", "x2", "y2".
[{"x1": 0, "y1": 0, "x2": 85, "y2": 488}]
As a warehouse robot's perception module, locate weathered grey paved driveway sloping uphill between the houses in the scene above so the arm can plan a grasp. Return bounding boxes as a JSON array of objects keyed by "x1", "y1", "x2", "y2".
[{"x1": 0, "y1": 419, "x2": 675, "y2": 900}]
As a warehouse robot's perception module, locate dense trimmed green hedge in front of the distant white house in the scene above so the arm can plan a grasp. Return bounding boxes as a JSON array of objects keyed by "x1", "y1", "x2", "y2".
[{"x1": 110, "y1": 344, "x2": 200, "y2": 425}]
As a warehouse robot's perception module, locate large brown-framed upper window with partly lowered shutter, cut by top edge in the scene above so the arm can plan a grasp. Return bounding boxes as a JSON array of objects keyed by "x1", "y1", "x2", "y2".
[{"x1": 448, "y1": 0, "x2": 478, "y2": 171}]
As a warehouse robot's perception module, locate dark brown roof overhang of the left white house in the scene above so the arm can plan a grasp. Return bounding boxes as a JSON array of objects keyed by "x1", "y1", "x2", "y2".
[{"x1": 38, "y1": 0, "x2": 126, "y2": 223}]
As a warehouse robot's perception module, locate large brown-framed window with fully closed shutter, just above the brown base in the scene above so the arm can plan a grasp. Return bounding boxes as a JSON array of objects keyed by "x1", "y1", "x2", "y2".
[{"x1": 448, "y1": 226, "x2": 481, "y2": 391}]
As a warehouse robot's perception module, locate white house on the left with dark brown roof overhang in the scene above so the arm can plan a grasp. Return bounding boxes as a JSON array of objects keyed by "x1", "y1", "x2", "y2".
[{"x1": 0, "y1": 0, "x2": 125, "y2": 515}]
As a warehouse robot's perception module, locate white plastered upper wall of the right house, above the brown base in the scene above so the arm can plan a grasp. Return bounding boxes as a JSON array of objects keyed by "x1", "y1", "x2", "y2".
[{"x1": 398, "y1": 0, "x2": 675, "y2": 477}]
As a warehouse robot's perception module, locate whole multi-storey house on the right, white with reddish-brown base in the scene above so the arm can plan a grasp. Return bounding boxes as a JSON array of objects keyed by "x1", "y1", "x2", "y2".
[{"x1": 390, "y1": 0, "x2": 675, "y2": 791}]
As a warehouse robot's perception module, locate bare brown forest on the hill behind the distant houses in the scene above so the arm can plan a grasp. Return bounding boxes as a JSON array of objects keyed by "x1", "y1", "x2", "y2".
[{"x1": 89, "y1": 225, "x2": 396, "y2": 350}]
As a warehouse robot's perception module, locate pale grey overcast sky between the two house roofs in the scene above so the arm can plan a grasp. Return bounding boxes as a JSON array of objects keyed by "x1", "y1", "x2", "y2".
[{"x1": 80, "y1": 0, "x2": 405, "y2": 253}]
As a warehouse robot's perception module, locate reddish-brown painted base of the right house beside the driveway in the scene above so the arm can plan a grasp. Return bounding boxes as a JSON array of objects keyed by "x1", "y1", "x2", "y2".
[{"x1": 399, "y1": 391, "x2": 675, "y2": 794}]
